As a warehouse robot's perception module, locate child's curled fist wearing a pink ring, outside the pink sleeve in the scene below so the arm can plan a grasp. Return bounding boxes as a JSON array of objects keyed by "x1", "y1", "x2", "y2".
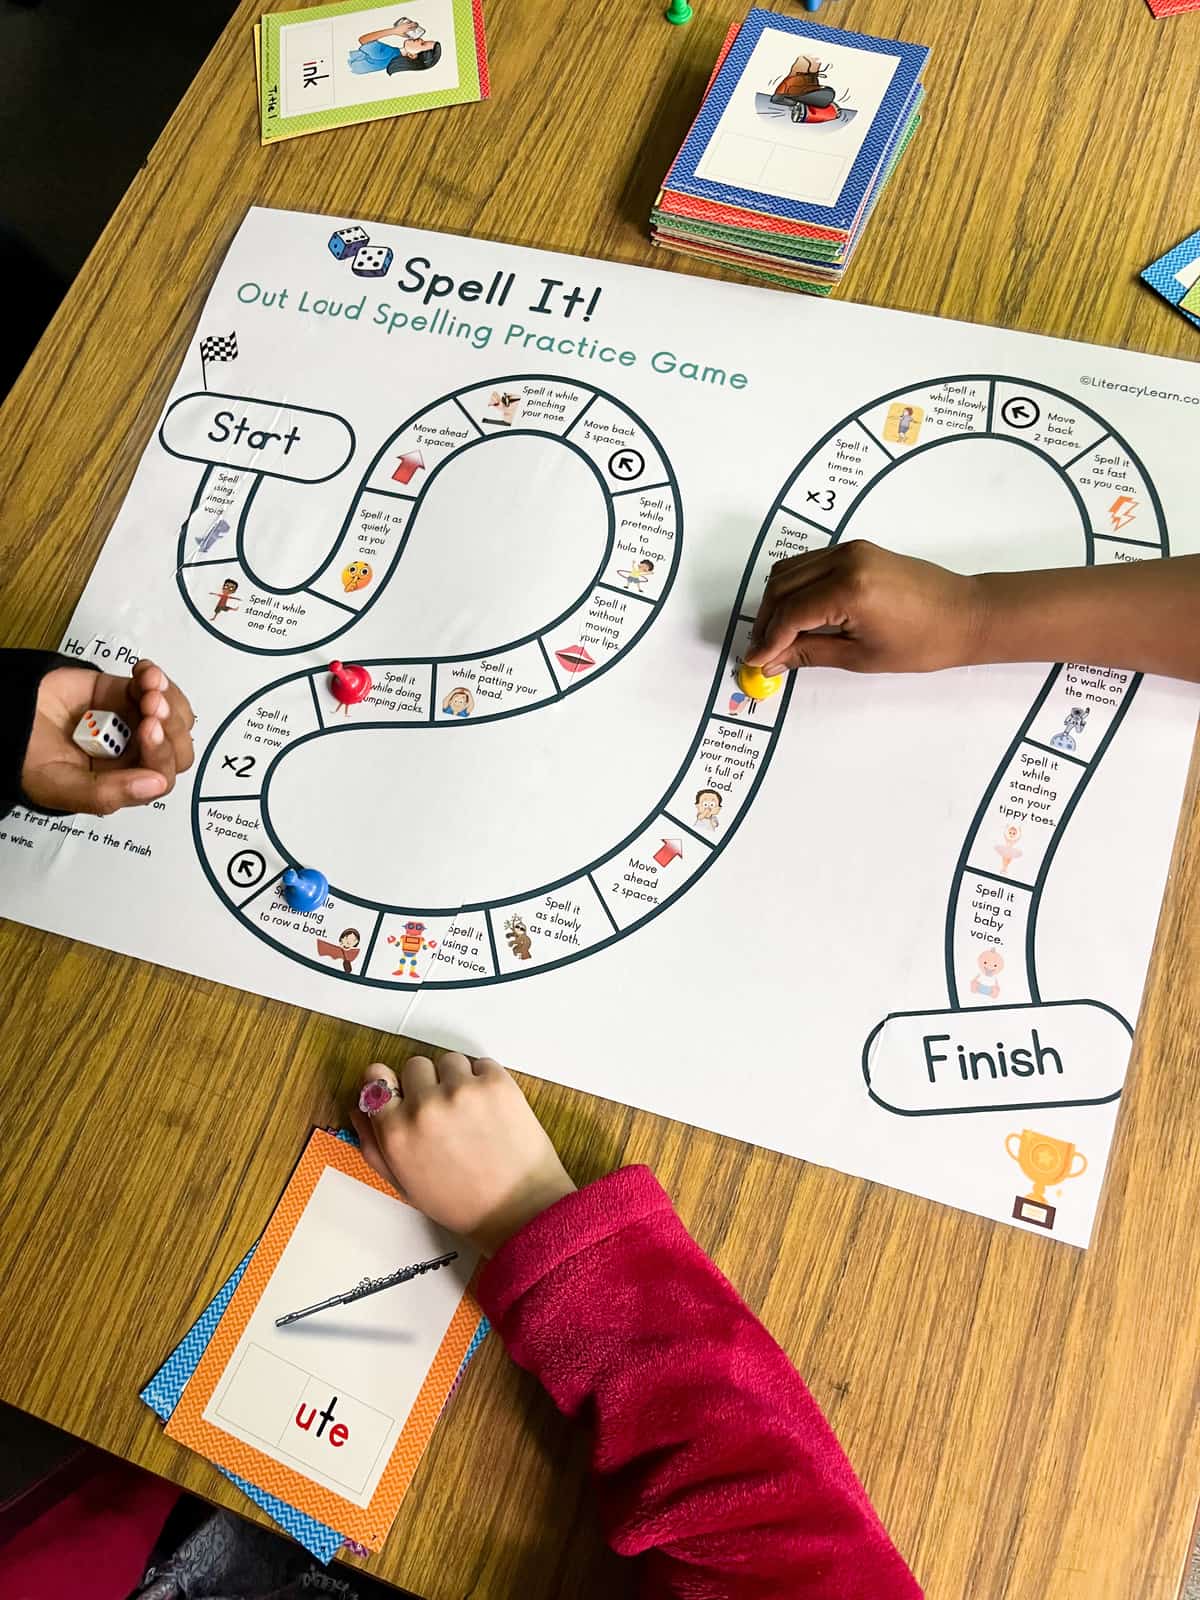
[{"x1": 352, "y1": 1051, "x2": 574, "y2": 1256}]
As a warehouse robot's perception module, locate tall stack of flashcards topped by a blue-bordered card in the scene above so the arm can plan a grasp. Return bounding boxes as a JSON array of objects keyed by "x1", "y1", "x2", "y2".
[{"x1": 651, "y1": 8, "x2": 930, "y2": 294}]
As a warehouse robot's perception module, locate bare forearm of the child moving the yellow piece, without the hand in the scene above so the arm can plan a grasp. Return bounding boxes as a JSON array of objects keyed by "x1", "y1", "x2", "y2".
[{"x1": 963, "y1": 555, "x2": 1200, "y2": 682}]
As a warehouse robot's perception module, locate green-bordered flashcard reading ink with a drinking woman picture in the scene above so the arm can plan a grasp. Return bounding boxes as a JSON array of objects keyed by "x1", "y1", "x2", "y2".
[{"x1": 259, "y1": 0, "x2": 488, "y2": 144}]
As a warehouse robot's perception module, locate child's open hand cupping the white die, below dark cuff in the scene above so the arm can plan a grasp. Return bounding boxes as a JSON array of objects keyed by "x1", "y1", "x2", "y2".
[{"x1": 21, "y1": 661, "x2": 195, "y2": 816}]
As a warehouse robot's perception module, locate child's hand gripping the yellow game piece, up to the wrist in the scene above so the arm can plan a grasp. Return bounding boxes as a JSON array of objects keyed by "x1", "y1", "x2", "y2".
[{"x1": 746, "y1": 539, "x2": 978, "y2": 677}]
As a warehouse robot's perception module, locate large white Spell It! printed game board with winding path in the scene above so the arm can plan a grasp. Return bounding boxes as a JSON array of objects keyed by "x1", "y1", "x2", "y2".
[{"x1": 0, "y1": 210, "x2": 1200, "y2": 1245}]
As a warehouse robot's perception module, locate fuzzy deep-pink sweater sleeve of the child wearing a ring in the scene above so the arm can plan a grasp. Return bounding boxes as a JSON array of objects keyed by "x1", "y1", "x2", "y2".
[{"x1": 478, "y1": 1166, "x2": 922, "y2": 1600}]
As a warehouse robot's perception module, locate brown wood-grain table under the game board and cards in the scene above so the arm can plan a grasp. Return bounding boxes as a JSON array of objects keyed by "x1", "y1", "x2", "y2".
[{"x1": 0, "y1": 0, "x2": 1200, "y2": 1600}]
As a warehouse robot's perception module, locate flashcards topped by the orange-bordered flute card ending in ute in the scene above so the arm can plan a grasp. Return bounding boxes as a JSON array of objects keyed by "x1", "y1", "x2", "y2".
[{"x1": 141, "y1": 1130, "x2": 486, "y2": 1562}]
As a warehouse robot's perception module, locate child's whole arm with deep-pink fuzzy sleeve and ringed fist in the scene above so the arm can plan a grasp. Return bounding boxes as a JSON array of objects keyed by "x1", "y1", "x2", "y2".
[{"x1": 352, "y1": 1051, "x2": 920, "y2": 1600}]
